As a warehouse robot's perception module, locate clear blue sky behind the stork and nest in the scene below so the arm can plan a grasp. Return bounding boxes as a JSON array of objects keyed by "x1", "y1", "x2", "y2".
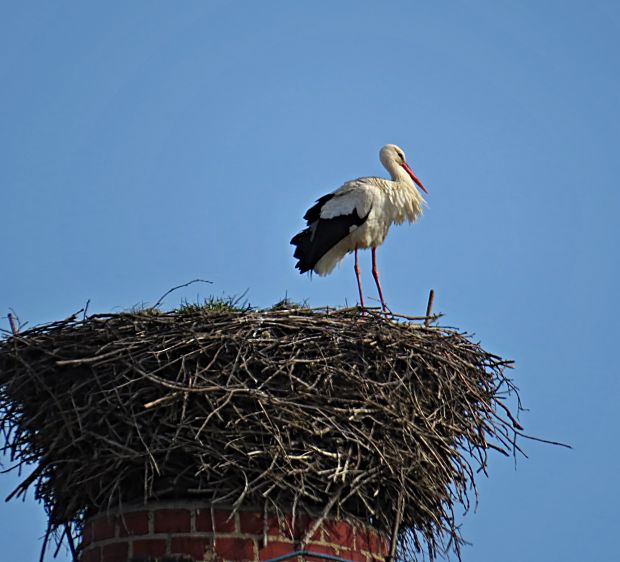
[{"x1": 0, "y1": 0, "x2": 620, "y2": 562}]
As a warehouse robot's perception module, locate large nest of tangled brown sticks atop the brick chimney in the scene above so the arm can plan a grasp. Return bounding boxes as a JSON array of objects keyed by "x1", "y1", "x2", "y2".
[{"x1": 0, "y1": 309, "x2": 519, "y2": 558}]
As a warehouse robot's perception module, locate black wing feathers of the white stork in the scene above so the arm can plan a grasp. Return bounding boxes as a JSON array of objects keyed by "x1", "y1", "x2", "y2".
[{"x1": 291, "y1": 193, "x2": 368, "y2": 273}]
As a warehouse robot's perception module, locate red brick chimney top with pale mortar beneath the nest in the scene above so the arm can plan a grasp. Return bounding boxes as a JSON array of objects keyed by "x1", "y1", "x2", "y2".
[{"x1": 80, "y1": 500, "x2": 388, "y2": 562}]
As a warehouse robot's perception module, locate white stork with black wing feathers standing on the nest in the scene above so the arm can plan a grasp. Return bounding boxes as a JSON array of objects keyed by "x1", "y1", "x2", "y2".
[{"x1": 291, "y1": 144, "x2": 428, "y2": 312}]
